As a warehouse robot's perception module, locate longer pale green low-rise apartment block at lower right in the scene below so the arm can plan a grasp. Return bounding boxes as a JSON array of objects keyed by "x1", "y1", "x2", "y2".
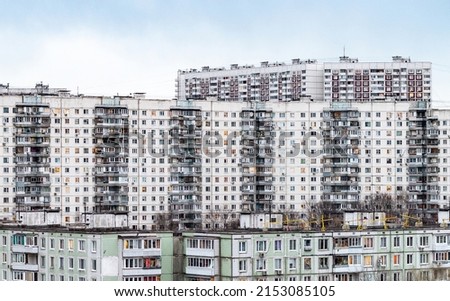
[{"x1": 178, "y1": 228, "x2": 450, "y2": 281}]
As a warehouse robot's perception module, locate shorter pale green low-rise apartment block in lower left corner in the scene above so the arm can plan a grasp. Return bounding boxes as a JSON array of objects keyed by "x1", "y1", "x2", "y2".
[{"x1": 0, "y1": 225, "x2": 173, "y2": 281}]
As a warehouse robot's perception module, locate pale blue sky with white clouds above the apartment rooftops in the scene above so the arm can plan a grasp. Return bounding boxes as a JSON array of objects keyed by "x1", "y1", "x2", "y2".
[{"x1": 0, "y1": 0, "x2": 450, "y2": 105}]
